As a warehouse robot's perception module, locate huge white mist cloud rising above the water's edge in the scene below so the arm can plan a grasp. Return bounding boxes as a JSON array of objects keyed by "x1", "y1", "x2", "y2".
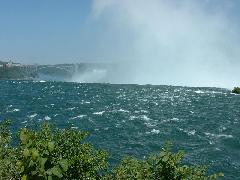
[{"x1": 92, "y1": 0, "x2": 240, "y2": 87}]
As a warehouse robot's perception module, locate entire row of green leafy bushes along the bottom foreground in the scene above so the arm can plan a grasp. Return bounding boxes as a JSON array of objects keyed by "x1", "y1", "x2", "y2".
[{"x1": 0, "y1": 121, "x2": 223, "y2": 180}]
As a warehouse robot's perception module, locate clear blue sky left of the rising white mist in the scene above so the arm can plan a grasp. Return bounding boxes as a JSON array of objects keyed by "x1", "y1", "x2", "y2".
[{"x1": 0, "y1": 0, "x2": 91, "y2": 63}]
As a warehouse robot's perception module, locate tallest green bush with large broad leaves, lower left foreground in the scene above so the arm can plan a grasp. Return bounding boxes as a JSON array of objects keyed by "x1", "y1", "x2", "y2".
[{"x1": 15, "y1": 124, "x2": 107, "y2": 179}]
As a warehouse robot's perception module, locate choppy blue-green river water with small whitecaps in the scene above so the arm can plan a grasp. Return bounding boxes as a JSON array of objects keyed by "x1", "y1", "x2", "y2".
[{"x1": 0, "y1": 81, "x2": 240, "y2": 179}]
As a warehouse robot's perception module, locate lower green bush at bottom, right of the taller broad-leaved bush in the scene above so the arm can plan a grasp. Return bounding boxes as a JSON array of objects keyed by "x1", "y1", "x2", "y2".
[{"x1": 106, "y1": 143, "x2": 223, "y2": 180}]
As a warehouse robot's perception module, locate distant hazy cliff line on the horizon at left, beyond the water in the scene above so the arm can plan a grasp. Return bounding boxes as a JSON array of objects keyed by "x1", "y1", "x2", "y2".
[{"x1": 0, "y1": 61, "x2": 109, "y2": 82}]
